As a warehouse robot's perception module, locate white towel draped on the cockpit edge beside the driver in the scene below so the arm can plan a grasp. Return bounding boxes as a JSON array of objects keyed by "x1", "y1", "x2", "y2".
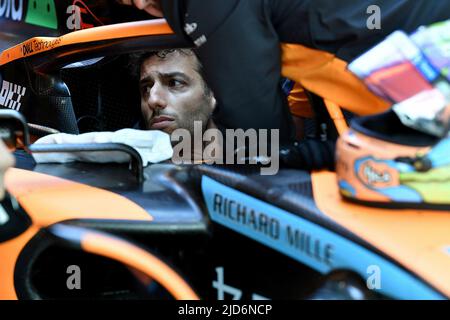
[{"x1": 33, "y1": 129, "x2": 173, "y2": 166}]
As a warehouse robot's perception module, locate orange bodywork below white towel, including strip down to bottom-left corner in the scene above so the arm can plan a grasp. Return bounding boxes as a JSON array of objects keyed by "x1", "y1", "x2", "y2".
[{"x1": 0, "y1": 169, "x2": 152, "y2": 300}]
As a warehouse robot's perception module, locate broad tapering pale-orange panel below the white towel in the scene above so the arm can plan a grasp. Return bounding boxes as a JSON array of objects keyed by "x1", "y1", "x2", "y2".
[{"x1": 5, "y1": 168, "x2": 153, "y2": 227}]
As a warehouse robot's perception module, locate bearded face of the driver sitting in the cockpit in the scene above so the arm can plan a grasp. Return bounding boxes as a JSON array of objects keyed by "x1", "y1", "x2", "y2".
[{"x1": 140, "y1": 51, "x2": 215, "y2": 134}]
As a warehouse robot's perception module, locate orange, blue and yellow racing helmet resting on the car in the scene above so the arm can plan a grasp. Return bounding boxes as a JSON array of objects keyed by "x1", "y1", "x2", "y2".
[{"x1": 336, "y1": 111, "x2": 450, "y2": 210}]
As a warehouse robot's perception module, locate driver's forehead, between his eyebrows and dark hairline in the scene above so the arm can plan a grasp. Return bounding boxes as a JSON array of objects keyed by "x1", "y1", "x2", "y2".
[{"x1": 141, "y1": 52, "x2": 199, "y2": 79}]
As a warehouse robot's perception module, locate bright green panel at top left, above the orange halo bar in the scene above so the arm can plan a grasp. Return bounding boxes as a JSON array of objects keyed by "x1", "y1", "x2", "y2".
[{"x1": 25, "y1": 0, "x2": 58, "y2": 29}]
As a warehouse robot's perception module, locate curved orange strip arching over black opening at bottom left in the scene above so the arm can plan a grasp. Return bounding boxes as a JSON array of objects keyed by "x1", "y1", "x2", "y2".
[{"x1": 81, "y1": 233, "x2": 199, "y2": 300}]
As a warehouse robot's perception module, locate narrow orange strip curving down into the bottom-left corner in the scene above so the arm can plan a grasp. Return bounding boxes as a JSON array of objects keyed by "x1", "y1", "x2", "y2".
[{"x1": 0, "y1": 227, "x2": 39, "y2": 300}]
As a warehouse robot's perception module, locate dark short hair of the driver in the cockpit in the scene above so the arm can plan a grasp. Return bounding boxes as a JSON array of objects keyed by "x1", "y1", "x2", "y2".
[{"x1": 129, "y1": 49, "x2": 212, "y2": 96}]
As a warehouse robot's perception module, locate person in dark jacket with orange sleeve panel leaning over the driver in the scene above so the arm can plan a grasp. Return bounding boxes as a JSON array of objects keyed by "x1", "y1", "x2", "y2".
[{"x1": 119, "y1": 0, "x2": 450, "y2": 140}]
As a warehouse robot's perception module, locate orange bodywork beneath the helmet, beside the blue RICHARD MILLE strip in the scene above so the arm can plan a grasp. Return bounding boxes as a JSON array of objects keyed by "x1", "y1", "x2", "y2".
[{"x1": 312, "y1": 172, "x2": 450, "y2": 297}]
